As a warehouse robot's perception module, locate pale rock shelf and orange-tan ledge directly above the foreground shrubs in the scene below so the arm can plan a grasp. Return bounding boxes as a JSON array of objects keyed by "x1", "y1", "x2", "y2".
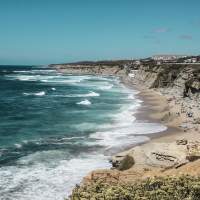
[{"x1": 77, "y1": 139, "x2": 200, "y2": 187}]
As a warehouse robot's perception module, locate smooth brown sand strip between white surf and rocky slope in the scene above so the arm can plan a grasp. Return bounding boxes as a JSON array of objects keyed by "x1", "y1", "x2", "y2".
[{"x1": 122, "y1": 76, "x2": 183, "y2": 149}]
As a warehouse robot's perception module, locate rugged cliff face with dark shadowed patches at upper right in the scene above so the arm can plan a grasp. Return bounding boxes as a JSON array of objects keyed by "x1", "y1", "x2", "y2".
[{"x1": 130, "y1": 64, "x2": 200, "y2": 99}]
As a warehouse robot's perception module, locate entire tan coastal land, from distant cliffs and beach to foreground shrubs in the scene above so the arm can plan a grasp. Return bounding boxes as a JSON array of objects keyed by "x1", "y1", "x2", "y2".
[{"x1": 51, "y1": 60, "x2": 200, "y2": 200}]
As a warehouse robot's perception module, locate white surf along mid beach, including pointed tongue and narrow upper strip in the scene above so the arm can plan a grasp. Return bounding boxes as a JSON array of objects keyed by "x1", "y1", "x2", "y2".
[{"x1": 90, "y1": 93, "x2": 167, "y2": 153}]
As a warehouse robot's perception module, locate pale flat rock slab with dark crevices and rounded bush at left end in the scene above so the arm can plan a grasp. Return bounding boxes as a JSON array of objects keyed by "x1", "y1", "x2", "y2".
[{"x1": 111, "y1": 139, "x2": 200, "y2": 170}]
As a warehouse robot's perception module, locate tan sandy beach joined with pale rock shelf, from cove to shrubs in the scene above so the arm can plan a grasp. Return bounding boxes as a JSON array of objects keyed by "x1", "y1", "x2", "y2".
[{"x1": 80, "y1": 76, "x2": 200, "y2": 184}]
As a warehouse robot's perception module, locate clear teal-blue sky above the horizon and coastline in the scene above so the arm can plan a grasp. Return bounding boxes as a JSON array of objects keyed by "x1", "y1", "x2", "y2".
[{"x1": 0, "y1": 0, "x2": 200, "y2": 64}]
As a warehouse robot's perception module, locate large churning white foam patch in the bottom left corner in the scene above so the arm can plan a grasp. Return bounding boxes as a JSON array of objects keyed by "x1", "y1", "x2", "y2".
[{"x1": 0, "y1": 151, "x2": 110, "y2": 200}]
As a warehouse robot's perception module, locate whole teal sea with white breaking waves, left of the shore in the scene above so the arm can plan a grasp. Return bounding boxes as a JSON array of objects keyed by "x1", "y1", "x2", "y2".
[{"x1": 0, "y1": 66, "x2": 166, "y2": 200}]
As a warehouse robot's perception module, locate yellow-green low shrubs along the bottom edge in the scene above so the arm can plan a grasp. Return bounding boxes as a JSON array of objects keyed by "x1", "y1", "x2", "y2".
[{"x1": 71, "y1": 176, "x2": 200, "y2": 200}]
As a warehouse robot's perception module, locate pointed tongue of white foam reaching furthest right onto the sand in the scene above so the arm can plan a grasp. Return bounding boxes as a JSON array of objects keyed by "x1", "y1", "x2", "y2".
[{"x1": 90, "y1": 122, "x2": 167, "y2": 153}]
